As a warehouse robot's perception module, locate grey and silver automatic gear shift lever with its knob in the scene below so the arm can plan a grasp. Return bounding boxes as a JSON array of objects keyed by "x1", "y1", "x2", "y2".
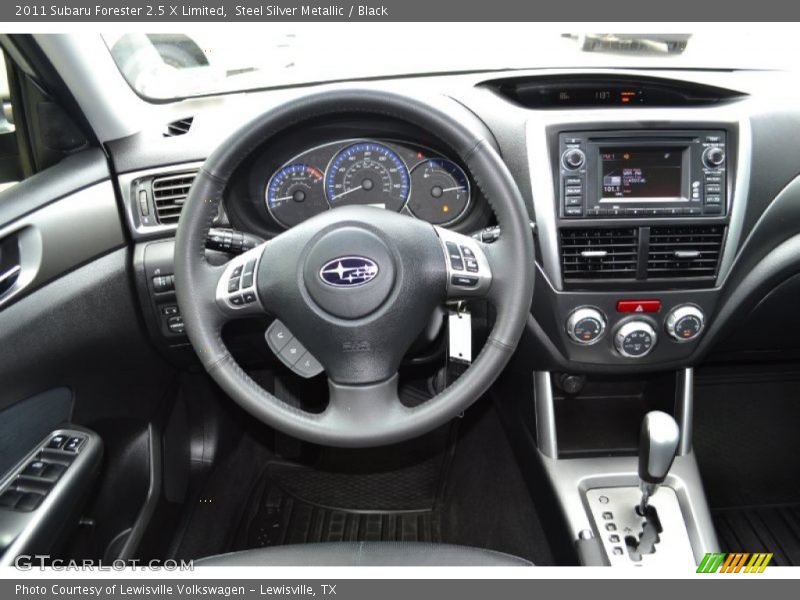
[{"x1": 639, "y1": 410, "x2": 680, "y2": 515}]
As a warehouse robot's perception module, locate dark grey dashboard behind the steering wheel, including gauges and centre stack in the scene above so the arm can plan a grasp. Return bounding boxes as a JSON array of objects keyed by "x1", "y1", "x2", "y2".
[{"x1": 111, "y1": 71, "x2": 800, "y2": 373}]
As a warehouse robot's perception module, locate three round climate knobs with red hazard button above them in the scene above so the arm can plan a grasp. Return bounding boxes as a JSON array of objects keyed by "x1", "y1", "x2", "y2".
[{"x1": 566, "y1": 299, "x2": 705, "y2": 360}]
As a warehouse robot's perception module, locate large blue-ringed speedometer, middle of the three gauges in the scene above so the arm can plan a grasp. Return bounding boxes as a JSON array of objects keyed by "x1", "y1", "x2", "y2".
[{"x1": 325, "y1": 142, "x2": 411, "y2": 212}]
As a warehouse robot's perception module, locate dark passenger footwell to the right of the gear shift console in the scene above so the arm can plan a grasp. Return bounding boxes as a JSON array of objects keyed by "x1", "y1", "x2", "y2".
[{"x1": 693, "y1": 365, "x2": 800, "y2": 565}]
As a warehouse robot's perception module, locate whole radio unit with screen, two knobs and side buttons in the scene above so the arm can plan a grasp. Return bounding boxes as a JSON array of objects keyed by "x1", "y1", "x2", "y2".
[{"x1": 558, "y1": 130, "x2": 727, "y2": 219}]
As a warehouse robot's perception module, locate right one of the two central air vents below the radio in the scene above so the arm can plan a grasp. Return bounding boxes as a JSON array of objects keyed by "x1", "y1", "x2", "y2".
[{"x1": 647, "y1": 225, "x2": 725, "y2": 279}]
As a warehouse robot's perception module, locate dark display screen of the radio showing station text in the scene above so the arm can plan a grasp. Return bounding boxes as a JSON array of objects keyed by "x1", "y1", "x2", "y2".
[{"x1": 600, "y1": 147, "x2": 683, "y2": 202}]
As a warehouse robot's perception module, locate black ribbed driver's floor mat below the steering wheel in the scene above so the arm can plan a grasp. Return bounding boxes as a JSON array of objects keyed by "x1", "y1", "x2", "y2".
[{"x1": 231, "y1": 425, "x2": 456, "y2": 550}]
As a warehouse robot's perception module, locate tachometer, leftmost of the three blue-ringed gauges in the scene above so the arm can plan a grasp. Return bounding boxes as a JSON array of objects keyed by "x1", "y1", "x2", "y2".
[{"x1": 266, "y1": 164, "x2": 330, "y2": 227}]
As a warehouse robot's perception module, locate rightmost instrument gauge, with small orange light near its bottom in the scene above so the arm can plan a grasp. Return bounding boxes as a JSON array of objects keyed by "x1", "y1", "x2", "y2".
[{"x1": 408, "y1": 158, "x2": 470, "y2": 225}]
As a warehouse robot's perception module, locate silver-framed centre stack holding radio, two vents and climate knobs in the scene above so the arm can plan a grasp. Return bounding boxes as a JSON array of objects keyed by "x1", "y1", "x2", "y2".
[{"x1": 527, "y1": 105, "x2": 750, "y2": 372}]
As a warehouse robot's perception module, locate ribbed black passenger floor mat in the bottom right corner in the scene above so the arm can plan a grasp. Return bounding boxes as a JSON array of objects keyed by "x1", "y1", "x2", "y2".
[{"x1": 713, "y1": 504, "x2": 800, "y2": 566}]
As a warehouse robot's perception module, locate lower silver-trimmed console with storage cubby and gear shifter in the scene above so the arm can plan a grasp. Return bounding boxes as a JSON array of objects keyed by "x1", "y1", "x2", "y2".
[{"x1": 534, "y1": 369, "x2": 719, "y2": 569}]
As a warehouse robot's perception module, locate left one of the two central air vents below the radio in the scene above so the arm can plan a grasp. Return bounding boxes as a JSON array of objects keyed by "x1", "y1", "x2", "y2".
[{"x1": 561, "y1": 227, "x2": 639, "y2": 281}]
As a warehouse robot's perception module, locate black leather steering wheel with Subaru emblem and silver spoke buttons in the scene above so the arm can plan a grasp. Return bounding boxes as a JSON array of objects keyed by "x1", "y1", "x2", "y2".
[{"x1": 175, "y1": 89, "x2": 534, "y2": 447}]
